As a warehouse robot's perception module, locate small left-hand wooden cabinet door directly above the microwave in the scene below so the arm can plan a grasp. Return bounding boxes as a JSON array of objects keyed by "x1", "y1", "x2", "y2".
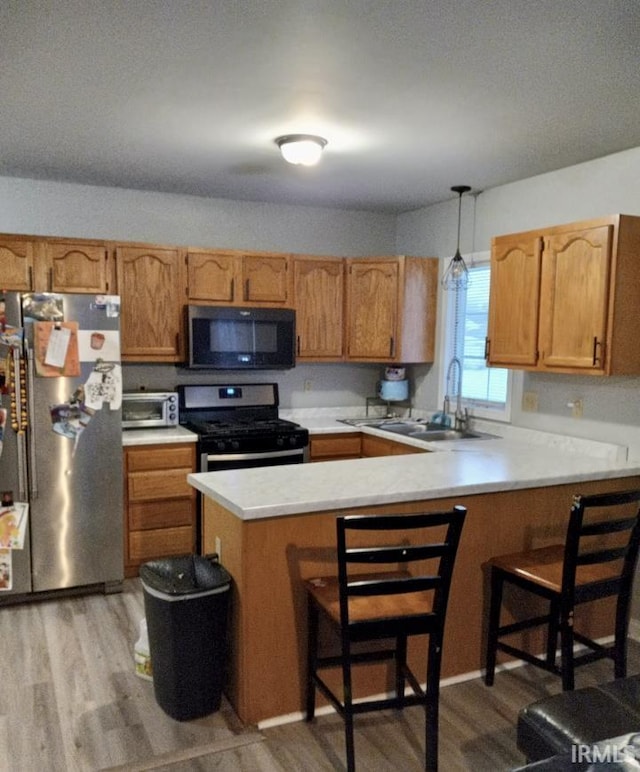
[{"x1": 187, "y1": 252, "x2": 241, "y2": 303}]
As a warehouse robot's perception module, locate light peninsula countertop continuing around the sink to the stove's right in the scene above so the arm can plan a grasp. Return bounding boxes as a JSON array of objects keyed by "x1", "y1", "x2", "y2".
[{"x1": 187, "y1": 409, "x2": 640, "y2": 520}]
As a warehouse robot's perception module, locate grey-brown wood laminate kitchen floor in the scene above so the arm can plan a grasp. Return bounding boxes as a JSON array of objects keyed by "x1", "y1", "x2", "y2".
[{"x1": 0, "y1": 580, "x2": 640, "y2": 772}]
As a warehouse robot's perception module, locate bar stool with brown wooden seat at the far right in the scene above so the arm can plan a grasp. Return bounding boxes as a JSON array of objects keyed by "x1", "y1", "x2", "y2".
[{"x1": 484, "y1": 490, "x2": 640, "y2": 690}]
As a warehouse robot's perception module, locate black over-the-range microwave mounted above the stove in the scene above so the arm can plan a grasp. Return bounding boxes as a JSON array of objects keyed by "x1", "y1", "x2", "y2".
[{"x1": 187, "y1": 306, "x2": 296, "y2": 370}]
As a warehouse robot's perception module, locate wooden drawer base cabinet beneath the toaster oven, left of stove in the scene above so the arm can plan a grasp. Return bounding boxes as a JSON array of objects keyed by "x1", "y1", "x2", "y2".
[{"x1": 124, "y1": 443, "x2": 197, "y2": 577}]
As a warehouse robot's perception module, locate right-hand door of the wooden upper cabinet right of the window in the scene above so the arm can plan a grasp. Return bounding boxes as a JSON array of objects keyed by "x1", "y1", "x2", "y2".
[{"x1": 540, "y1": 225, "x2": 613, "y2": 371}]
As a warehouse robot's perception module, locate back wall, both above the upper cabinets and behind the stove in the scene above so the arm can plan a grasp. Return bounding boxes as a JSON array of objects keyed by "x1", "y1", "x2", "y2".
[{"x1": 0, "y1": 177, "x2": 396, "y2": 407}]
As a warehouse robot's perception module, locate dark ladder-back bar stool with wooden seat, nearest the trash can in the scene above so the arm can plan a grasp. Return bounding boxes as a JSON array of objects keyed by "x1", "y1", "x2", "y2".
[{"x1": 306, "y1": 506, "x2": 466, "y2": 772}]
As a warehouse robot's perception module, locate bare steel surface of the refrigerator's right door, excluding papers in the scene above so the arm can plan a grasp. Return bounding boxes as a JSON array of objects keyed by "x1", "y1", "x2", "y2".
[{"x1": 27, "y1": 295, "x2": 124, "y2": 592}]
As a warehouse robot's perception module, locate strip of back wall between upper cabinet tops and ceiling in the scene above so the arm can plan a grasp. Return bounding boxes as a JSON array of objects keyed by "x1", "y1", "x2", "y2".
[{"x1": 0, "y1": 177, "x2": 395, "y2": 256}]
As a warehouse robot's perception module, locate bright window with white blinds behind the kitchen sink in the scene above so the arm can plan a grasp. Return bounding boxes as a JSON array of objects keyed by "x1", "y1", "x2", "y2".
[{"x1": 442, "y1": 253, "x2": 511, "y2": 421}]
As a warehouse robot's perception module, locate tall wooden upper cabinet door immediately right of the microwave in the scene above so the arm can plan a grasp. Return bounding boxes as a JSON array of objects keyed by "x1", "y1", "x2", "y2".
[{"x1": 293, "y1": 258, "x2": 344, "y2": 360}]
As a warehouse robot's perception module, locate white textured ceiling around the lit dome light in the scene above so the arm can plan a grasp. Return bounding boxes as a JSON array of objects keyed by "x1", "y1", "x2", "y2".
[{"x1": 0, "y1": 0, "x2": 640, "y2": 212}]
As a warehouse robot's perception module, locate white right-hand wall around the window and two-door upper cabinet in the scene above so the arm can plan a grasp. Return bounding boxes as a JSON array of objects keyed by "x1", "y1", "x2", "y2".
[{"x1": 396, "y1": 148, "x2": 640, "y2": 459}]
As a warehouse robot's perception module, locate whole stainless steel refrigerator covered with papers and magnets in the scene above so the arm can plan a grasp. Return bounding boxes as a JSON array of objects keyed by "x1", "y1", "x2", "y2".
[{"x1": 0, "y1": 292, "x2": 123, "y2": 604}]
